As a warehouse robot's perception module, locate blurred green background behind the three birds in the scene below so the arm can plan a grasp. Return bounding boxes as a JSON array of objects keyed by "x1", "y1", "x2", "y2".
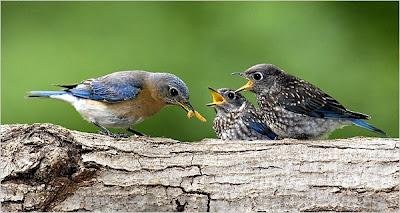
[{"x1": 1, "y1": 2, "x2": 399, "y2": 141}]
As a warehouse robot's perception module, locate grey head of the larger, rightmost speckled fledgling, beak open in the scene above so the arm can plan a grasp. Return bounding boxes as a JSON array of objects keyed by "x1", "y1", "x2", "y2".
[{"x1": 232, "y1": 64, "x2": 285, "y2": 93}]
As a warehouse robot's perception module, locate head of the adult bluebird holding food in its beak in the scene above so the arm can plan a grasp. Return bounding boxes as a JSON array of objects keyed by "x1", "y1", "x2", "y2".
[{"x1": 151, "y1": 73, "x2": 205, "y2": 122}]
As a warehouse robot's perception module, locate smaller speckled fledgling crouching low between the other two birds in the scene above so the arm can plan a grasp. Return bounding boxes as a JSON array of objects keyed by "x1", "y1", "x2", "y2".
[{"x1": 207, "y1": 88, "x2": 277, "y2": 140}]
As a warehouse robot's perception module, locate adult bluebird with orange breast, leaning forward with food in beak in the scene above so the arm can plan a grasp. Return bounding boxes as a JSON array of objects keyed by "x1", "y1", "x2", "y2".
[{"x1": 29, "y1": 71, "x2": 205, "y2": 137}]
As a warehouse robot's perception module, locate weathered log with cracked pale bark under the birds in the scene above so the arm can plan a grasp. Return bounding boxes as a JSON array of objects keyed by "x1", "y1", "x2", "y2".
[{"x1": 0, "y1": 124, "x2": 399, "y2": 212}]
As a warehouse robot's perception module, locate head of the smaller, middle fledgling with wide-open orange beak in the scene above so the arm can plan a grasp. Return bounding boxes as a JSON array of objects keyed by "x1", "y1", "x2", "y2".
[{"x1": 207, "y1": 87, "x2": 246, "y2": 113}]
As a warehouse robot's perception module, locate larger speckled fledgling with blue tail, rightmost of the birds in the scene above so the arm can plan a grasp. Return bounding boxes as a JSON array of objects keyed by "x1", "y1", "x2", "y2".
[{"x1": 234, "y1": 64, "x2": 385, "y2": 139}]
